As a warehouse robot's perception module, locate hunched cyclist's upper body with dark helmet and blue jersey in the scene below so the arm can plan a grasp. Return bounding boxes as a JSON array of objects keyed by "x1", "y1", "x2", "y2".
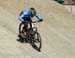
[{"x1": 18, "y1": 8, "x2": 43, "y2": 42}]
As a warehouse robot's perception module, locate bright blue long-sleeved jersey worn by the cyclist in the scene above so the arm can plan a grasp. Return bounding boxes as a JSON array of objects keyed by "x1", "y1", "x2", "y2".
[{"x1": 18, "y1": 9, "x2": 42, "y2": 21}]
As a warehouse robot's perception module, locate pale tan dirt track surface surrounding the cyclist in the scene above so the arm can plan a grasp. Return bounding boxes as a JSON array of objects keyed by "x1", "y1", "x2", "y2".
[{"x1": 0, "y1": 0, "x2": 75, "y2": 58}]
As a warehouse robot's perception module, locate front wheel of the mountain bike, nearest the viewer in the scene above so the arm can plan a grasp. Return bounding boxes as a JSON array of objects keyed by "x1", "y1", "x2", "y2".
[{"x1": 31, "y1": 32, "x2": 42, "y2": 50}]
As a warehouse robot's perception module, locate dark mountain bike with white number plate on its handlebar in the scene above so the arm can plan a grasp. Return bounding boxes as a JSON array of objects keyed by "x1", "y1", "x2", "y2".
[{"x1": 19, "y1": 21, "x2": 42, "y2": 50}]
